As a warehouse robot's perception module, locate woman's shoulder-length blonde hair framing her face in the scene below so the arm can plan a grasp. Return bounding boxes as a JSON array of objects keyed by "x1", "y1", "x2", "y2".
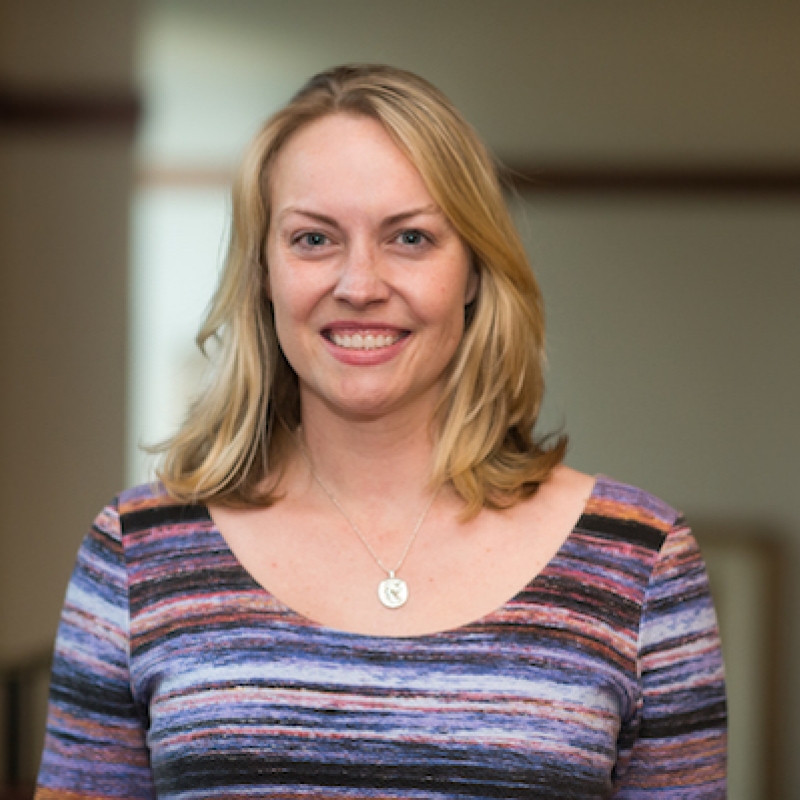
[{"x1": 158, "y1": 65, "x2": 566, "y2": 518}]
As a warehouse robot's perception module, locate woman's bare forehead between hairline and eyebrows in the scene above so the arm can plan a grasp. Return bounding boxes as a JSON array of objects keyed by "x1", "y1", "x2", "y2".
[{"x1": 269, "y1": 114, "x2": 433, "y2": 217}]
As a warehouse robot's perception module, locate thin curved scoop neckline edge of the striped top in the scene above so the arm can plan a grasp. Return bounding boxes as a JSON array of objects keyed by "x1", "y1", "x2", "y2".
[{"x1": 202, "y1": 474, "x2": 609, "y2": 643}]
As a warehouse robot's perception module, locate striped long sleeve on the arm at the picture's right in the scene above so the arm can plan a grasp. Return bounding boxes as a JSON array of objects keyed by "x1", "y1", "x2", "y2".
[{"x1": 613, "y1": 521, "x2": 727, "y2": 800}]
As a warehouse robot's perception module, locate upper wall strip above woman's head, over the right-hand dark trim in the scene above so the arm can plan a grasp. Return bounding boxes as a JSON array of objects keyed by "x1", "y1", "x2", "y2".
[{"x1": 138, "y1": 0, "x2": 800, "y2": 166}]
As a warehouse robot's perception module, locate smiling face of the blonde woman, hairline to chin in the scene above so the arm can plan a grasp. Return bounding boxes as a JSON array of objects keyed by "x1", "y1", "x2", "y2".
[{"x1": 267, "y1": 114, "x2": 477, "y2": 418}]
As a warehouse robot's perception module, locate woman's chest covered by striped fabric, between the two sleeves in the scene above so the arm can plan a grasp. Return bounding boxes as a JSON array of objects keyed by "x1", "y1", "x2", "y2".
[{"x1": 131, "y1": 524, "x2": 638, "y2": 798}]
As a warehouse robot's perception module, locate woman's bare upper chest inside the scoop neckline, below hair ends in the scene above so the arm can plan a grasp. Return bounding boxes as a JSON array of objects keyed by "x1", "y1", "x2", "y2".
[{"x1": 213, "y1": 488, "x2": 581, "y2": 636}]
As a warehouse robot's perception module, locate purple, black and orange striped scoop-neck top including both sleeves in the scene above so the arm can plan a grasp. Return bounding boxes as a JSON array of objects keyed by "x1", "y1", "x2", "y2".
[{"x1": 36, "y1": 478, "x2": 726, "y2": 800}]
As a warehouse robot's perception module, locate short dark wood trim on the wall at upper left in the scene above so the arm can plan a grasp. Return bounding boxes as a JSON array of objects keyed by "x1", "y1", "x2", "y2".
[{"x1": 0, "y1": 86, "x2": 142, "y2": 136}]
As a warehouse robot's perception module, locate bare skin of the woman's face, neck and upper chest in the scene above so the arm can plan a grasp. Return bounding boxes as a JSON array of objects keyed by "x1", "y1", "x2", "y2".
[{"x1": 211, "y1": 114, "x2": 594, "y2": 636}]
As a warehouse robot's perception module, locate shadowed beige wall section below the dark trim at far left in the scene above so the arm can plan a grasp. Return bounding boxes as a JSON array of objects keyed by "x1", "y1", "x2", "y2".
[{"x1": 0, "y1": 133, "x2": 130, "y2": 658}]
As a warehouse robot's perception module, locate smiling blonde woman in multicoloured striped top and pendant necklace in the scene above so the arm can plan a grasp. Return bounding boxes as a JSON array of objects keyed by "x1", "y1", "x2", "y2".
[{"x1": 37, "y1": 66, "x2": 725, "y2": 800}]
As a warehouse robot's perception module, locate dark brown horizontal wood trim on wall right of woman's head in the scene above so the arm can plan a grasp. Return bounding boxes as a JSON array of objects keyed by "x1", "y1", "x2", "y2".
[{"x1": 503, "y1": 164, "x2": 800, "y2": 194}]
